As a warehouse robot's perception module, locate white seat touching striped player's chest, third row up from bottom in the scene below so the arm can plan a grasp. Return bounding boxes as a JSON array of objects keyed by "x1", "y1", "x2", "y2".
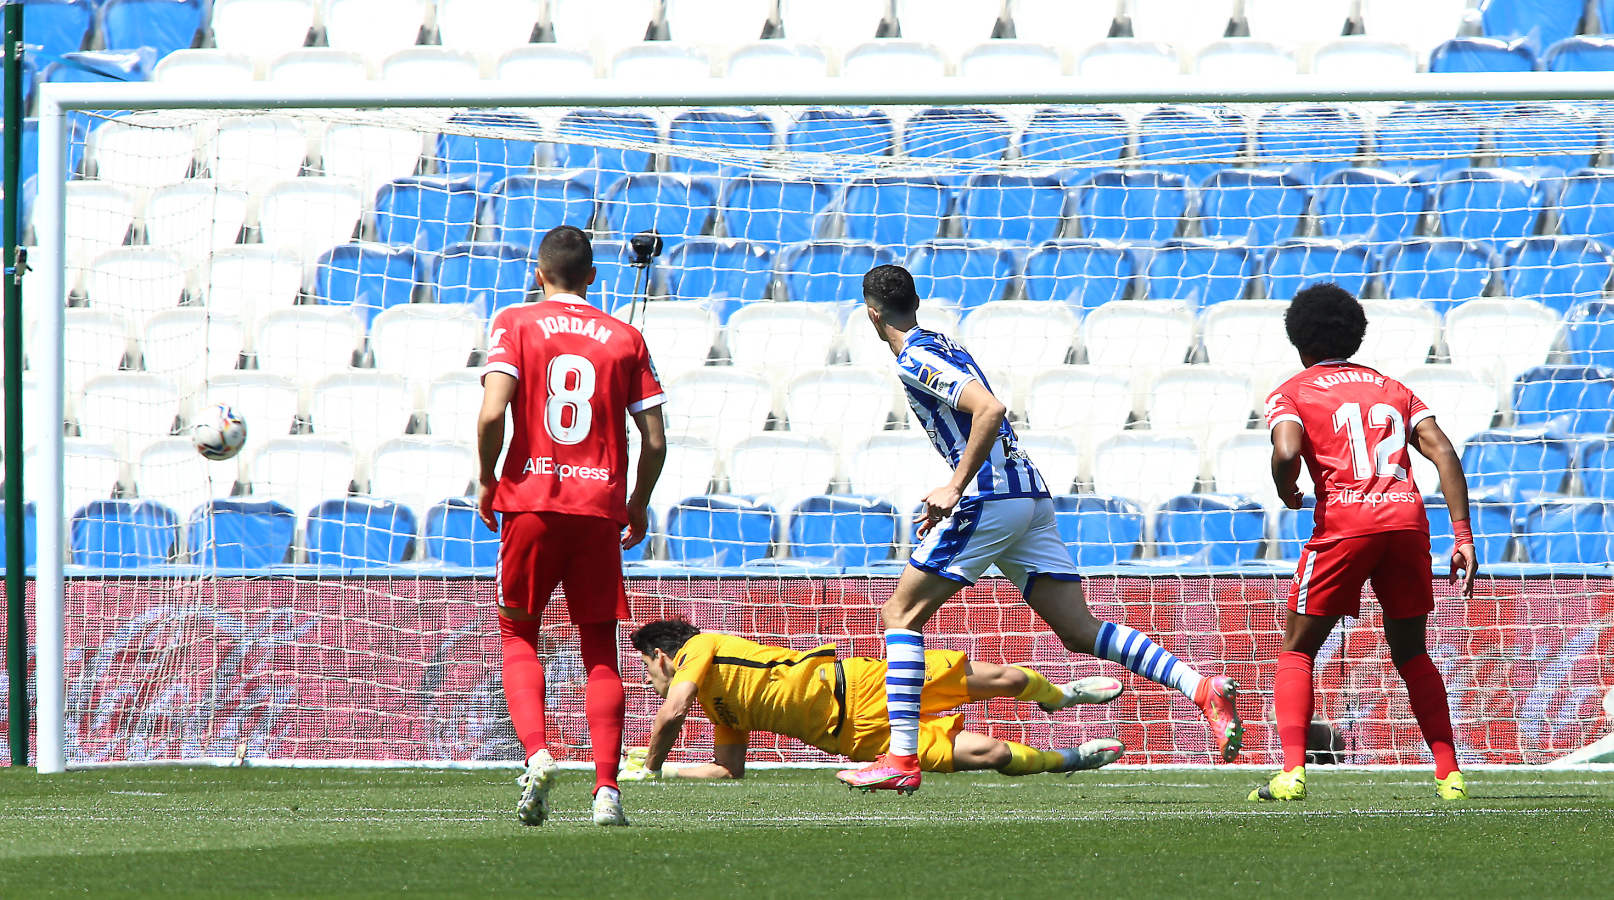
[{"x1": 781, "y1": 366, "x2": 896, "y2": 458}]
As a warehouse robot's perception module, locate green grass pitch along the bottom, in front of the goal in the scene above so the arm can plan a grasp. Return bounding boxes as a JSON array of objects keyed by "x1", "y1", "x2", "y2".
[{"x1": 0, "y1": 768, "x2": 1614, "y2": 900}]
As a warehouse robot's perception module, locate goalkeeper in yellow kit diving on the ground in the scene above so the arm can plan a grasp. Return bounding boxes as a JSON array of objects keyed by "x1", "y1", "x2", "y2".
[{"x1": 620, "y1": 619, "x2": 1125, "y2": 781}]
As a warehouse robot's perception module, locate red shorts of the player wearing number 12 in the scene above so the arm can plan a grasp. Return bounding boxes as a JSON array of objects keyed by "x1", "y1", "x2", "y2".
[{"x1": 1290, "y1": 531, "x2": 1435, "y2": 619}]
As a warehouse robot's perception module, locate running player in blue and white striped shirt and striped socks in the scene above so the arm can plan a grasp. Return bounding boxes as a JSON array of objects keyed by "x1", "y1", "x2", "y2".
[{"x1": 838, "y1": 266, "x2": 1244, "y2": 792}]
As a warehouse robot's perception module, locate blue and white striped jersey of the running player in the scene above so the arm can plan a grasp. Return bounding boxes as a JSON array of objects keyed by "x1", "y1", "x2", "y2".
[{"x1": 897, "y1": 327, "x2": 1047, "y2": 500}]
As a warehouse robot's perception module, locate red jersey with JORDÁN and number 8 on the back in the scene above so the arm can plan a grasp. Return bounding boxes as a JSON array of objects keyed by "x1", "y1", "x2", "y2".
[{"x1": 483, "y1": 294, "x2": 665, "y2": 524}]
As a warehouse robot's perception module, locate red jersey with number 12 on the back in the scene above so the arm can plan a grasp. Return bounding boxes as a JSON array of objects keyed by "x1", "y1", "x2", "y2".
[{"x1": 1267, "y1": 360, "x2": 1435, "y2": 544}]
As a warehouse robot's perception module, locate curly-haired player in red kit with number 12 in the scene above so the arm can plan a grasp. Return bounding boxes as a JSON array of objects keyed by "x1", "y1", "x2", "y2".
[{"x1": 1249, "y1": 284, "x2": 1478, "y2": 800}]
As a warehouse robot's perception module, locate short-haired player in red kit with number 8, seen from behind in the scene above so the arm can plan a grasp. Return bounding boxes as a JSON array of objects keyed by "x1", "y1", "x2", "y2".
[{"x1": 476, "y1": 226, "x2": 667, "y2": 824}]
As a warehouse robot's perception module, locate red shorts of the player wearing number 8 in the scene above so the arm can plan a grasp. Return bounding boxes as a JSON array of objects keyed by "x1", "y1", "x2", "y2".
[{"x1": 499, "y1": 513, "x2": 628, "y2": 624}]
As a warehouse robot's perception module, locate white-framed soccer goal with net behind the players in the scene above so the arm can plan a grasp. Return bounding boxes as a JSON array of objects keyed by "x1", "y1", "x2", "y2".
[{"x1": 24, "y1": 74, "x2": 1614, "y2": 771}]
